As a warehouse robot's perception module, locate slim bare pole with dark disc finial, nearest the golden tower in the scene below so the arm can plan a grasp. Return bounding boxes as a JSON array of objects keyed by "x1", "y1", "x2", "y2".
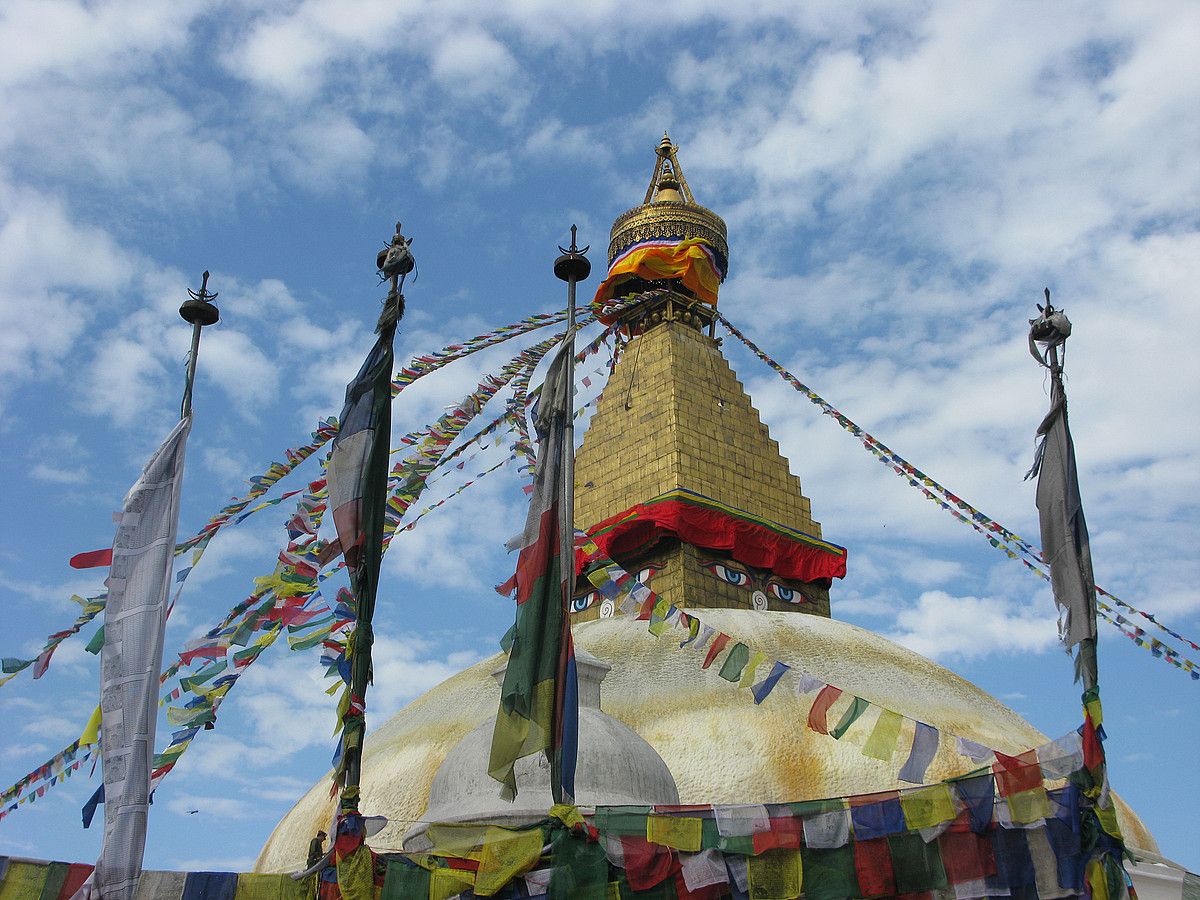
[{"x1": 550, "y1": 224, "x2": 592, "y2": 803}]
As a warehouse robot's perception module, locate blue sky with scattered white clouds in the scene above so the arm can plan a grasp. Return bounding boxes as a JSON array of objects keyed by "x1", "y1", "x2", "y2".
[{"x1": 0, "y1": 0, "x2": 1200, "y2": 871}]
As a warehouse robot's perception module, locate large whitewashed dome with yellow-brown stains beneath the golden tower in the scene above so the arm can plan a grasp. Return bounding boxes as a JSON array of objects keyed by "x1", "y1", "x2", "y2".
[{"x1": 254, "y1": 614, "x2": 1158, "y2": 872}]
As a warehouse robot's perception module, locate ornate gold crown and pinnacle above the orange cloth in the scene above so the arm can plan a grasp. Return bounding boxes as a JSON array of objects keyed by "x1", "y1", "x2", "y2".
[{"x1": 608, "y1": 132, "x2": 730, "y2": 270}]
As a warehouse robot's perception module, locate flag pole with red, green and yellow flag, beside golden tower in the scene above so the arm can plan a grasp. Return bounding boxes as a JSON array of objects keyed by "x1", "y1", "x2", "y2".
[{"x1": 487, "y1": 226, "x2": 592, "y2": 803}]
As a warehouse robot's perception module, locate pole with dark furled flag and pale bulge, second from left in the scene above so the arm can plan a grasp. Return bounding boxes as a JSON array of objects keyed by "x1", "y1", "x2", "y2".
[{"x1": 328, "y1": 222, "x2": 415, "y2": 815}]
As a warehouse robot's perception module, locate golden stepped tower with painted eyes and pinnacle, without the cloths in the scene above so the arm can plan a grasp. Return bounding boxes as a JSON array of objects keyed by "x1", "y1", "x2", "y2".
[{"x1": 575, "y1": 136, "x2": 829, "y2": 622}]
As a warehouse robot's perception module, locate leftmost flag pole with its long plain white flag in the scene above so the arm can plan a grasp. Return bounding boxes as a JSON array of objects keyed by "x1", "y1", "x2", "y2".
[{"x1": 77, "y1": 272, "x2": 220, "y2": 900}]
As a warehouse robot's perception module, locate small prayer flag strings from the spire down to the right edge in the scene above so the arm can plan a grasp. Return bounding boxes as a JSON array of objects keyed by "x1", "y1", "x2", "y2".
[{"x1": 716, "y1": 311, "x2": 1200, "y2": 680}]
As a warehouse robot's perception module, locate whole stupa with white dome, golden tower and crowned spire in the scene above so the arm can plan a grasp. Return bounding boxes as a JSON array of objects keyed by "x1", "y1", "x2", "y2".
[{"x1": 257, "y1": 137, "x2": 1158, "y2": 872}]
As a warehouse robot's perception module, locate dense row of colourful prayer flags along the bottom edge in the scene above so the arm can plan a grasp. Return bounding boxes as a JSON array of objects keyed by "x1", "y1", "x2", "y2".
[{"x1": 37, "y1": 770, "x2": 1130, "y2": 900}]
